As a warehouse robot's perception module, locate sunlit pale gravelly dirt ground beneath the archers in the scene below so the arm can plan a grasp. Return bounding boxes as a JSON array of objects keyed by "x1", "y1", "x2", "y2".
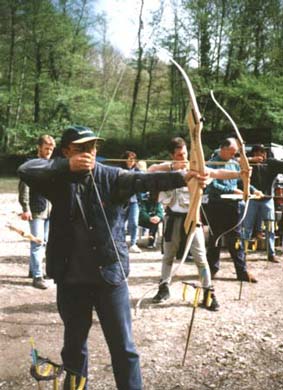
[{"x1": 0, "y1": 193, "x2": 283, "y2": 390}]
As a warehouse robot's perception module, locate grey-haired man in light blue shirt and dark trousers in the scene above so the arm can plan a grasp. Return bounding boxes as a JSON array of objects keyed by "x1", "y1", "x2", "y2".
[{"x1": 205, "y1": 138, "x2": 260, "y2": 283}]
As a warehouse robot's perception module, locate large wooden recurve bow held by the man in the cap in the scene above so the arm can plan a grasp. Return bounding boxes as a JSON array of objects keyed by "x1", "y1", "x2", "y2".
[{"x1": 166, "y1": 57, "x2": 205, "y2": 278}]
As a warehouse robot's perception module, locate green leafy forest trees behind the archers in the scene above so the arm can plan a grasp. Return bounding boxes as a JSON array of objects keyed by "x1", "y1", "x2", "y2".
[{"x1": 0, "y1": 0, "x2": 283, "y2": 174}]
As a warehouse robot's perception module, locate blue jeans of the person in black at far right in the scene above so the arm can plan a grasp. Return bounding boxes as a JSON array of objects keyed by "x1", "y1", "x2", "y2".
[{"x1": 243, "y1": 199, "x2": 275, "y2": 256}]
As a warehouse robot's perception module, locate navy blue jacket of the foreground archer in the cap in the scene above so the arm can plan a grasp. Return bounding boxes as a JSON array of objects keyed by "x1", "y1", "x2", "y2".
[{"x1": 18, "y1": 158, "x2": 185, "y2": 285}]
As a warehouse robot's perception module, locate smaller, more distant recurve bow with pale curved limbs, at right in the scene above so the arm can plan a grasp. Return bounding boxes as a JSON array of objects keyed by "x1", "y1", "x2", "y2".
[{"x1": 210, "y1": 90, "x2": 250, "y2": 246}]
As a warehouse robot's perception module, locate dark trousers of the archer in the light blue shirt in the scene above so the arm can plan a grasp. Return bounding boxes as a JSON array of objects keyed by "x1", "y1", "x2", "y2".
[{"x1": 205, "y1": 201, "x2": 247, "y2": 277}]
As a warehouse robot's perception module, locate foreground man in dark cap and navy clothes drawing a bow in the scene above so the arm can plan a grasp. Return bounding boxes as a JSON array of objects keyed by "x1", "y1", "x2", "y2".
[{"x1": 18, "y1": 126, "x2": 209, "y2": 390}]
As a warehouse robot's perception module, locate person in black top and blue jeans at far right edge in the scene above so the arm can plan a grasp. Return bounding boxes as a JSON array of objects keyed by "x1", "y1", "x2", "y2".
[{"x1": 243, "y1": 145, "x2": 283, "y2": 263}]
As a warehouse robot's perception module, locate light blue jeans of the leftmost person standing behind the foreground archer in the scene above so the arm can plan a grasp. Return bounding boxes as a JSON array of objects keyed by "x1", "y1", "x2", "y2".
[{"x1": 29, "y1": 218, "x2": 49, "y2": 278}]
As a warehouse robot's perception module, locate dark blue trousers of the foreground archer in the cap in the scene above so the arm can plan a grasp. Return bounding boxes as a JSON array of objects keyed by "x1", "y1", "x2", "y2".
[{"x1": 57, "y1": 281, "x2": 142, "y2": 390}]
